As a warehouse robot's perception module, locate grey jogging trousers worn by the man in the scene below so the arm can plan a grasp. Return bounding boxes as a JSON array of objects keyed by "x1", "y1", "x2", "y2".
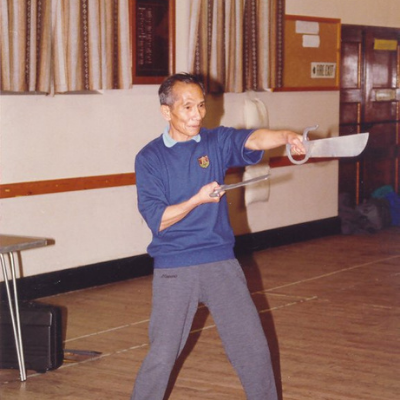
[{"x1": 131, "y1": 259, "x2": 277, "y2": 400}]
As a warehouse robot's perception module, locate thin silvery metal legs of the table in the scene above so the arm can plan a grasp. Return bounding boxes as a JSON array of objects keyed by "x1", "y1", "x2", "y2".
[{"x1": 0, "y1": 252, "x2": 26, "y2": 382}]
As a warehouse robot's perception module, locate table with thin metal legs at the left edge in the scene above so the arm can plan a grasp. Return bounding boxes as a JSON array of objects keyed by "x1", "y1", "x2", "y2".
[{"x1": 0, "y1": 235, "x2": 55, "y2": 382}]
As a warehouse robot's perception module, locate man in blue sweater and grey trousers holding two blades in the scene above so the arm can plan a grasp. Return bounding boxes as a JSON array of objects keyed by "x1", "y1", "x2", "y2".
[{"x1": 131, "y1": 73, "x2": 305, "y2": 400}]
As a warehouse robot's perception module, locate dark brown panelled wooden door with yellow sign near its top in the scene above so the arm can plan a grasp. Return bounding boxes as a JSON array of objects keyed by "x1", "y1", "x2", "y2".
[{"x1": 339, "y1": 25, "x2": 400, "y2": 203}]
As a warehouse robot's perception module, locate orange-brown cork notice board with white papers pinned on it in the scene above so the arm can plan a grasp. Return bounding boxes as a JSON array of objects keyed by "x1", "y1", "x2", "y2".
[{"x1": 282, "y1": 15, "x2": 340, "y2": 90}]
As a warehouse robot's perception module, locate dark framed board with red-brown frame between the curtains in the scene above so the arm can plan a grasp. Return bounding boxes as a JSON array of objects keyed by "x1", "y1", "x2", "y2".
[{"x1": 131, "y1": 0, "x2": 175, "y2": 84}]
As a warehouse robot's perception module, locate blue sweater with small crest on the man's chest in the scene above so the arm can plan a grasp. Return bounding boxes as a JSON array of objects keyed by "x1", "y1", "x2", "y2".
[{"x1": 135, "y1": 126, "x2": 263, "y2": 268}]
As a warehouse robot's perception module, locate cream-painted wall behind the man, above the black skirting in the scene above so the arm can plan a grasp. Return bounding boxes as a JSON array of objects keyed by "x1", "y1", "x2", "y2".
[{"x1": 0, "y1": 0, "x2": 400, "y2": 276}]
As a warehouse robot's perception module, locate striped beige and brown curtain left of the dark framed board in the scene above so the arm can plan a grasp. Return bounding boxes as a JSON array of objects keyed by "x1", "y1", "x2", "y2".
[{"x1": 0, "y1": 0, "x2": 131, "y2": 93}]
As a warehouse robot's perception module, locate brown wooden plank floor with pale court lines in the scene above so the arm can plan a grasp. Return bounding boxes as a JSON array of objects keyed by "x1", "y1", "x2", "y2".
[{"x1": 0, "y1": 228, "x2": 400, "y2": 400}]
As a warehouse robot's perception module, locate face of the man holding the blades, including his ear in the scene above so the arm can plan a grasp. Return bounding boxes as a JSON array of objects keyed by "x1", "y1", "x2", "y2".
[{"x1": 161, "y1": 82, "x2": 206, "y2": 142}]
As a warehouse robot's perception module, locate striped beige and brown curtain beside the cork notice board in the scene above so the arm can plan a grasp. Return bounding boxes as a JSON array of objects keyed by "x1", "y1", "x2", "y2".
[{"x1": 188, "y1": 0, "x2": 284, "y2": 92}]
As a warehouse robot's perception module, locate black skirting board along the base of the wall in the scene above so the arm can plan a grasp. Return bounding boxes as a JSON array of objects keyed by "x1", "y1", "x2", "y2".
[{"x1": 0, "y1": 217, "x2": 340, "y2": 300}]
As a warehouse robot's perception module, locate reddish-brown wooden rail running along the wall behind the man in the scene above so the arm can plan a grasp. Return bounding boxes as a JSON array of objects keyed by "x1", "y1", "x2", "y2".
[{"x1": 0, "y1": 157, "x2": 332, "y2": 199}]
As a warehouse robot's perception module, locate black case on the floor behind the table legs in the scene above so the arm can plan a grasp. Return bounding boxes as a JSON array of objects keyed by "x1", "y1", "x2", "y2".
[{"x1": 0, "y1": 302, "x2": 64, "y2": 372}]
